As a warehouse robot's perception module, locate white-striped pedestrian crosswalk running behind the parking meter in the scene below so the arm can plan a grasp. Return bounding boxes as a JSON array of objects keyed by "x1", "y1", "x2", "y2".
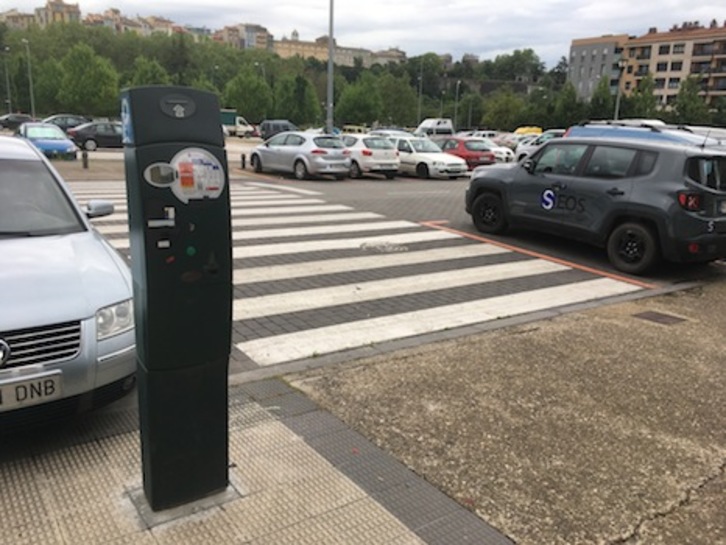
[{"x1": 70, "y1": 182, "x2": 643, "y2": 366}]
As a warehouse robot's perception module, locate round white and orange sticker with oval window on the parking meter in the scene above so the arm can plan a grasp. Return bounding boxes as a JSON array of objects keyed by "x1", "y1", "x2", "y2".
[{"x1": 144, "y1": 148, "x2": 225, "y2": 204}]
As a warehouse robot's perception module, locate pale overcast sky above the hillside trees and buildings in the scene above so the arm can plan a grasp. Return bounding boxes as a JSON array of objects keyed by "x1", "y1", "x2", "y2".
[{"x1": 5, "y1": 0, "x2": 726, "y2": 69}]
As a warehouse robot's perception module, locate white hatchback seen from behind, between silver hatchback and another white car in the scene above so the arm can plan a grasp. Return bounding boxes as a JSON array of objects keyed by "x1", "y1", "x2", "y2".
[{"x1": 341, "y1": 134, "x2": 401, "y2": 180}]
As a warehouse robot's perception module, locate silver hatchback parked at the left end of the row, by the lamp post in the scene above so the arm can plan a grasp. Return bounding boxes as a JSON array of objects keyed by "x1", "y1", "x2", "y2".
[{"x1": 250, "y1": 131, "x2": 350, "y2": 180}]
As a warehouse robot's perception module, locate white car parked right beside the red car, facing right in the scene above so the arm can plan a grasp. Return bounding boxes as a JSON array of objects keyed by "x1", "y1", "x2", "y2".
[{"x1": 393, "y1": 136, "x2": 469, "y2": 179}]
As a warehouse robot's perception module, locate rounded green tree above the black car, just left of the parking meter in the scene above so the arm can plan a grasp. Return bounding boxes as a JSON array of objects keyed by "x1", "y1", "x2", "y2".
[{"x1": 58, "y1": 44, "x2": 119, "y2": 116}]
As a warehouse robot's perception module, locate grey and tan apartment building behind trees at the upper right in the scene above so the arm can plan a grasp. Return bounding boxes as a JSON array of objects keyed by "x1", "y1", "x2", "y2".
[{"x1": 568, "y1": 20, "x2": 726, "y2": 108}]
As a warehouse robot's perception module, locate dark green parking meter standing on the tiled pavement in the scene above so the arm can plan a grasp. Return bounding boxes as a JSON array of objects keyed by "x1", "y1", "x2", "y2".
[{"x1": 121, "y1": 86, "x2": 232, "y2": 511}]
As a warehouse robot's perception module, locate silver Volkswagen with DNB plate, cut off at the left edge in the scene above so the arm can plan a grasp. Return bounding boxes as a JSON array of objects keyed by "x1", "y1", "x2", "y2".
[{"x1": 0, "y1": 136, "x2": 136, "y2": 432}]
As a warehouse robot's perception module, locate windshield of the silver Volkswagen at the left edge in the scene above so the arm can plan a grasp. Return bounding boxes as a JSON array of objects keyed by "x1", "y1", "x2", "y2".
[{"x1": 0, "y1": 159, "x2": 85, "y2": 237}]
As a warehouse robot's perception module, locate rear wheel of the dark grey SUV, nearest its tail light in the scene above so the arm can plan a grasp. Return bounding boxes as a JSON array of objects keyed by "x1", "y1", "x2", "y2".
[{"x1": 607, "y1": 222, "x2": 659, "y2": 274}]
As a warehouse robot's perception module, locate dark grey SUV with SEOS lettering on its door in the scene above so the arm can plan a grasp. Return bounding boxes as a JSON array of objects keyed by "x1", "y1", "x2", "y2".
[{"x1": 466, "y1": 134, "x2": 726, "y2": 274}]
